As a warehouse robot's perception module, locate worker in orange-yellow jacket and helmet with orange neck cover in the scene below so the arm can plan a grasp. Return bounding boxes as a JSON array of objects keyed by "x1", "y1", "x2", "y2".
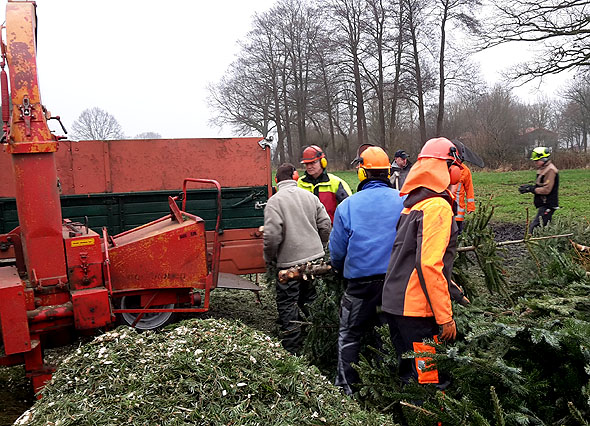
[{"x1": 382, "y1": 138, "x2": 463, "y2": 388}]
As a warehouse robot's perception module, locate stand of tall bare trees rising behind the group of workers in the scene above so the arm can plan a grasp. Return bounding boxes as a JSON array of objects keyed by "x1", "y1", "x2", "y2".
[{"x1": 210, "y1": 0, "x2": 536, "y2": 165}]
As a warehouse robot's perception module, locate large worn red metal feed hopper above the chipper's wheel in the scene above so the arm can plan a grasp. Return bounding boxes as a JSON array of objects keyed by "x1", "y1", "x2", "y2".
[{"x1": 109, "y1": 214, "x2": 208, "y2": 291}]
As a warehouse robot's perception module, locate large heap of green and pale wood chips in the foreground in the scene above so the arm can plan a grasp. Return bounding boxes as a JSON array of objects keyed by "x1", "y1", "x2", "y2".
[{"x1": 16, "y1": 319, "x2": 393, "y2": 425}]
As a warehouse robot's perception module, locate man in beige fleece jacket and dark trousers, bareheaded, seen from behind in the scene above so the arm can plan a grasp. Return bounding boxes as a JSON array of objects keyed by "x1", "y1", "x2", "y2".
[{"x1": 263, "y1": 163, "x2": 332, "y2": 353}]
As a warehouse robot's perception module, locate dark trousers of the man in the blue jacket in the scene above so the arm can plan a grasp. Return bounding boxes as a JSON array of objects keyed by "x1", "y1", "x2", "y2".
[{"x1": 334, "y1": 278, "x2": 385, "y2": 395}]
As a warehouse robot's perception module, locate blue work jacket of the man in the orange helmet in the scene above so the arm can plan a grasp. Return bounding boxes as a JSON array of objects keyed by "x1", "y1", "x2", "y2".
[{"x1": 329, "y1": 180, "x2": 404, "y2": 280}]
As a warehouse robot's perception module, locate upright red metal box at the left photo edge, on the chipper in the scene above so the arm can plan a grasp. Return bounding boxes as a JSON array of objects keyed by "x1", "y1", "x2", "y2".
[{"x1": 0, "y1": 266, "x2": 31, "y2": 355}]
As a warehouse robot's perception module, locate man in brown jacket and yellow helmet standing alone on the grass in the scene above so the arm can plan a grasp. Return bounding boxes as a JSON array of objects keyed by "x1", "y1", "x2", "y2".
[{"x1": 518, "y1": 146, "x2": 559, "y2": 233}]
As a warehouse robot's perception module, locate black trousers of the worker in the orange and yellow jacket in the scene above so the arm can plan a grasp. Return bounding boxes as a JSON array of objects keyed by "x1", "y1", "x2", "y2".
[{"x1": 383, "y1": 312, "x2": 443, "y2": 383}]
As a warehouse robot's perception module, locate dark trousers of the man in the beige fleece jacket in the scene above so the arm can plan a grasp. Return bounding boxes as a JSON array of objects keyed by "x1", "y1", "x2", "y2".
[{"x1": 276, "y1": 280, "x2": 317, "y2": 354}]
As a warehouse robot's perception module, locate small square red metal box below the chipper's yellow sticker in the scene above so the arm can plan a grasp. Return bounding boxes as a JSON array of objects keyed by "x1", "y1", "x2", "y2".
[{"x1": 72, "y1": 287, "x2": 112, "y2": 330}]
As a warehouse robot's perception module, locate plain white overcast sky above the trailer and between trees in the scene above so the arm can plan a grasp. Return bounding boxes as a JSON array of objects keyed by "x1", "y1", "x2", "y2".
[{"x1": 0, "y1": 0, "x2": 562, "y2": 138}]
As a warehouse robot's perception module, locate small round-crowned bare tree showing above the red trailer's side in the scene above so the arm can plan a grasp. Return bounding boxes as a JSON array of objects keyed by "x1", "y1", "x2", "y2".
[{"x1": 72, "y1": 107, "x2": 125, "y2": 140}]
